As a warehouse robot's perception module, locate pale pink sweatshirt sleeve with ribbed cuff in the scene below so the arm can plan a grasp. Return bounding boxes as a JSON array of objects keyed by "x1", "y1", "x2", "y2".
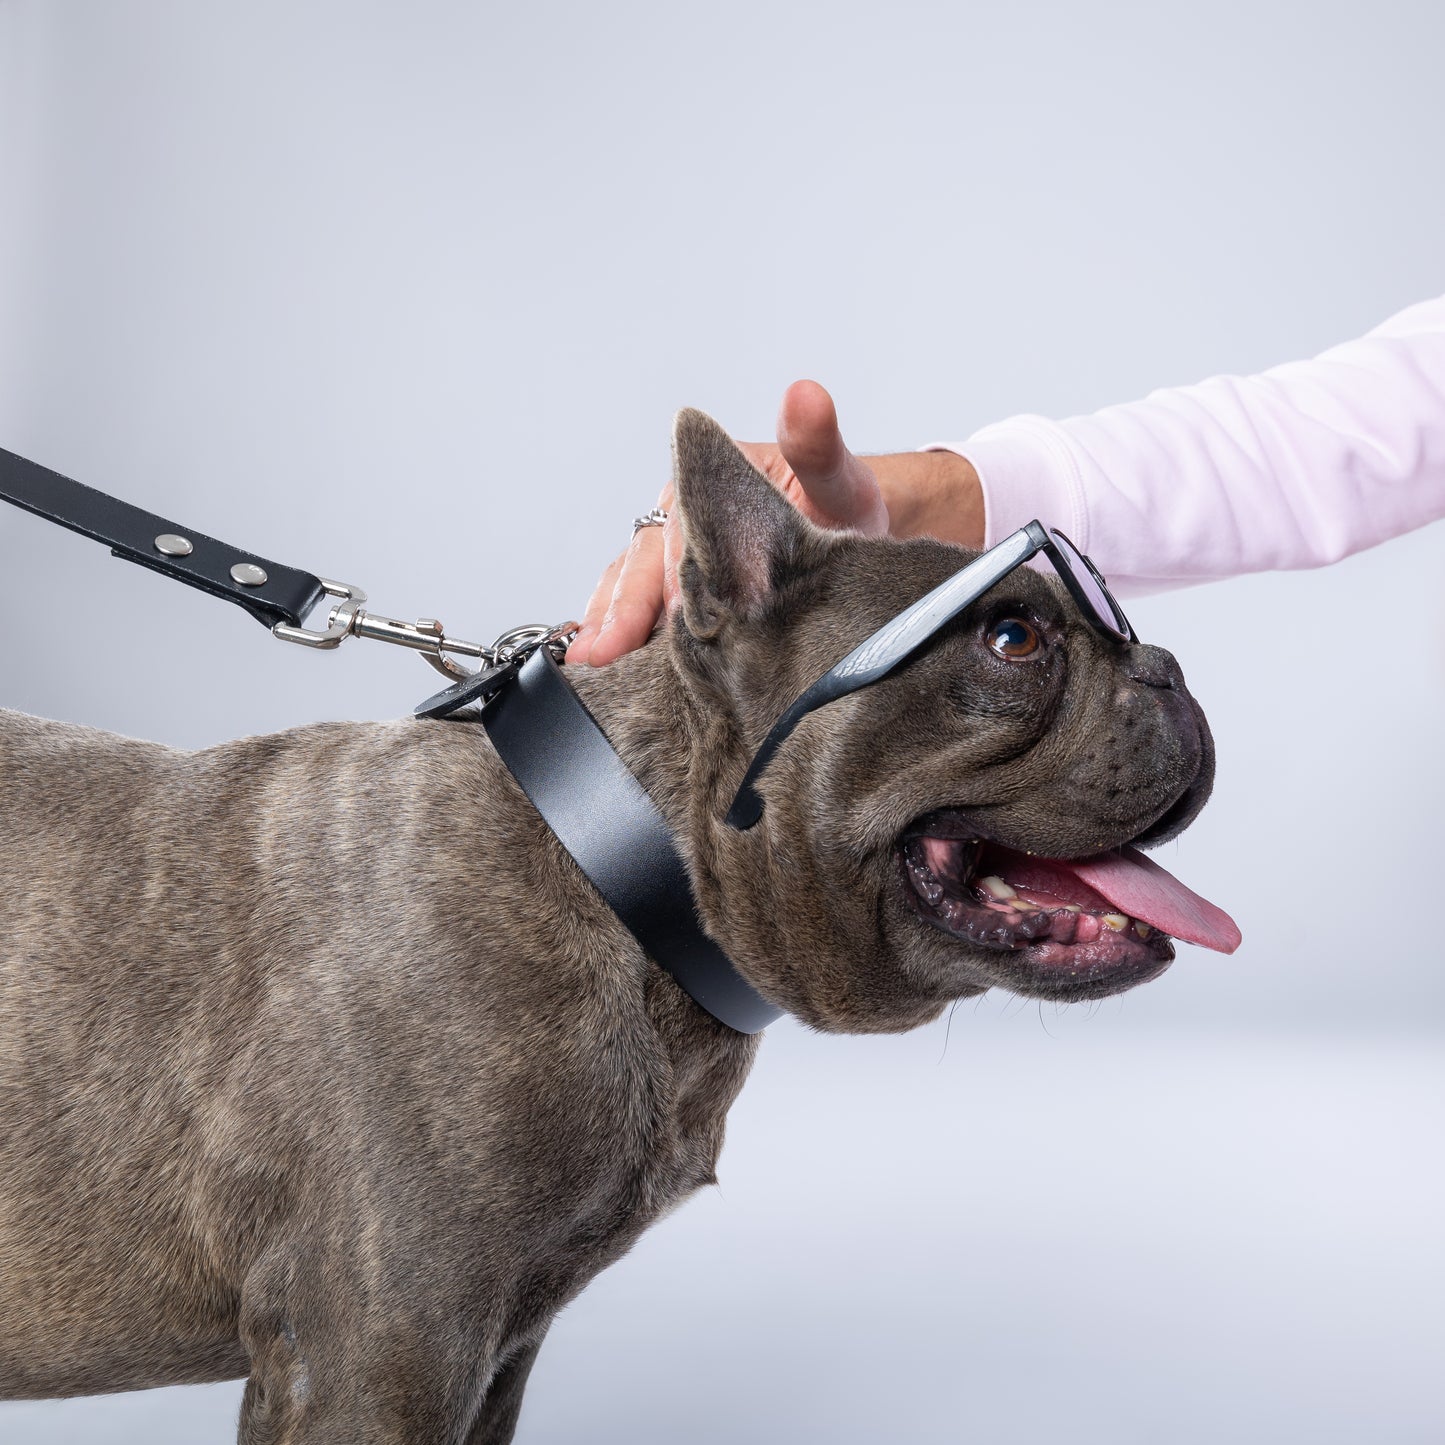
[{"x1": 946, "y1": 296, "x2": 1445, "y2": 594}]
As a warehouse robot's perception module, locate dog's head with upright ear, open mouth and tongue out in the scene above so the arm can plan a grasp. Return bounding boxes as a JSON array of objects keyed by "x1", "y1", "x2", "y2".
[{"x1": 661, "y1": 412, "x2": 1238, "y2": 1032}]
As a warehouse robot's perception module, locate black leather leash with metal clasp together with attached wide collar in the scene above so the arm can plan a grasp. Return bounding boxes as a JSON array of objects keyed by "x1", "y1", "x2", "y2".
[{"x1": 0, "y1": 448, "x2": 782, "y2": 1033}]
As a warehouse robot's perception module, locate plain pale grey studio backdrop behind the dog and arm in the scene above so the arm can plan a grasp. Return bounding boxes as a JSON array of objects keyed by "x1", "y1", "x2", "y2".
[{"x1": 0, "y1": 0, "x2": 1445, "y2": 1445}]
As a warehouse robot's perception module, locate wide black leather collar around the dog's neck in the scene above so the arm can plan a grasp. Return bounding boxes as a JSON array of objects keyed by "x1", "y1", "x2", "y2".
[{"x1": 481, "y1": 647, "x2": 782, "y2": 1033}]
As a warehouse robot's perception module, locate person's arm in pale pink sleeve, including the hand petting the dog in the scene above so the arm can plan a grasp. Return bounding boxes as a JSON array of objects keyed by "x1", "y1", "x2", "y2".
[{"x1": 569, "y1": 298, "x2": 1445, "y2": 663}]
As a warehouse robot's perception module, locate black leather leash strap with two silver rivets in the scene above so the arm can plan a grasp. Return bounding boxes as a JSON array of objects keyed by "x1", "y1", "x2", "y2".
[{"x1": 0, "y1": 448, "x2": 324, "y2": 627}]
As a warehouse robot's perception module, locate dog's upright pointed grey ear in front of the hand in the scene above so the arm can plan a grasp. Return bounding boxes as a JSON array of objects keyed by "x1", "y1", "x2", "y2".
[{"x1": 672, "y1": 407, "x2": 808, "y2": 637}]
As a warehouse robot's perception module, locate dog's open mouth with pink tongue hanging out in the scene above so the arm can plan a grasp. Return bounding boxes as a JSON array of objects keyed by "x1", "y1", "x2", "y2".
[{"x1": 900, "y1": 814, "x2": 1240, "y2": 987}]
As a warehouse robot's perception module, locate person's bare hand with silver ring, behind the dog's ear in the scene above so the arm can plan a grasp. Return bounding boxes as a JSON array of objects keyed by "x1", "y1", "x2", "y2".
[{"x1": 566, "y1": 381, "x2": 983, "y2": 668}]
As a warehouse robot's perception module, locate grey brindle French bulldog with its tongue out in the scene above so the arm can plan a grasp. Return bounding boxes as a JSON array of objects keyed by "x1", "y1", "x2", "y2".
[{"x1": 0, "y1": 412, "x2": 1231, "y2": 1445}]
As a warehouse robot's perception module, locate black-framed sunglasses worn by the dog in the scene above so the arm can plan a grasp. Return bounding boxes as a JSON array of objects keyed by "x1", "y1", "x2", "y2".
[{"x1": 727, "y1": 520, "x2": 1139, "y2": 829}]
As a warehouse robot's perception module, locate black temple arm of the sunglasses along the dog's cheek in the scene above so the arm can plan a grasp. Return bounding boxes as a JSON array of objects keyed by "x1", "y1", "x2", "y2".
[{"x1": 727, "y1": 522, "x2": 1048, "y2": 829}]
